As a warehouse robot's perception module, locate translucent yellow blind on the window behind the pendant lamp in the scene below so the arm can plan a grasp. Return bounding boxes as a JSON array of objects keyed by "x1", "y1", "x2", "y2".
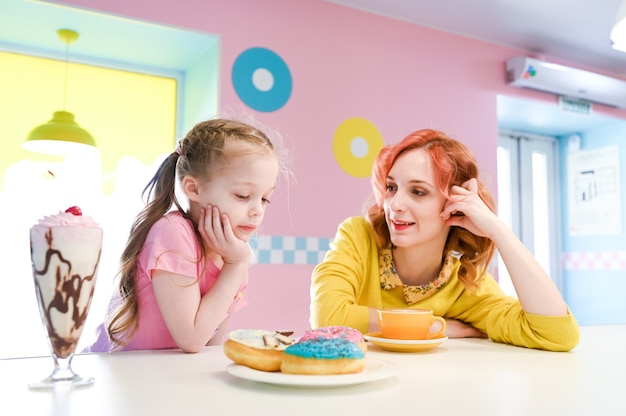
[{"x1": 0, "y1": 52, "x2": 177, "y2": 193}]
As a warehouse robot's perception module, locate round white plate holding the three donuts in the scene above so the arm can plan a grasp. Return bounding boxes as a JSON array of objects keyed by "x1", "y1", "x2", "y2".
[{"x1": 226, "y1": 358, "x2": 397, "y2": 387}]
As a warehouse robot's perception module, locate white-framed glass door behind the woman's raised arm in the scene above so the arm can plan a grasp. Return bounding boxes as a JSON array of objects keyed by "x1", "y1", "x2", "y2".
[{"x1": 497, "y1": 132, "x2": 561, "y2": 296}]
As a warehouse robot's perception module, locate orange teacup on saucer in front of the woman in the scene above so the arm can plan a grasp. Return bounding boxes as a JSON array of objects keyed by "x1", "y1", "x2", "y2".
[{"x1": 378, "y1": 309, "x2": 446, "y2": 340}]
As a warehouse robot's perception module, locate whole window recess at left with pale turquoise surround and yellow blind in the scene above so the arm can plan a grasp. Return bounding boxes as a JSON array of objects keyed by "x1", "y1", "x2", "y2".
[{"x1": 0, "y1": 1, "x2": 220, "y2": 358}]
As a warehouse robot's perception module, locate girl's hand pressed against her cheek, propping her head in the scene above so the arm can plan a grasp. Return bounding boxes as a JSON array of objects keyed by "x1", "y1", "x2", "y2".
[{"x1": 198, "y1": 205, "x2": 250, "y2": 264}]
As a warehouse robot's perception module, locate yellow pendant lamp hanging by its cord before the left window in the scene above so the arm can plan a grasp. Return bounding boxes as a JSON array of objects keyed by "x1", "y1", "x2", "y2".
[{"x1": 23, "y1": 29, "x2": 98, "y2": 156}]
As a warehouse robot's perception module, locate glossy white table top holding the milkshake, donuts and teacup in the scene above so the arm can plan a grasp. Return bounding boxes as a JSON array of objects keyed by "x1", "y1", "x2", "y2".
[{"x1": 0, "y1": 325, "x2": 626, "y2": 416}]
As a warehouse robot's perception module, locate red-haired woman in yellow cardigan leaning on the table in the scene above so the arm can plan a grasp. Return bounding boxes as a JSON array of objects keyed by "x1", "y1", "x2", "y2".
[{"x1": 311, "y1": 130, "x2": 579, "y2": 351}]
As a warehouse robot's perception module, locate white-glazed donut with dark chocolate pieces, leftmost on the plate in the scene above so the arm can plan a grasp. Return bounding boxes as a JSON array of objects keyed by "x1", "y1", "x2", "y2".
[{"x1": 223, "y1": 329, "x2": 295, "y2": 371}]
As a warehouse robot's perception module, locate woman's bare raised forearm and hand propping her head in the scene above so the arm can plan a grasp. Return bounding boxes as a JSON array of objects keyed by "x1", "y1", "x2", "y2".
[{"x1": 441, "y1": 179, "x2": 568, "y2": 316}]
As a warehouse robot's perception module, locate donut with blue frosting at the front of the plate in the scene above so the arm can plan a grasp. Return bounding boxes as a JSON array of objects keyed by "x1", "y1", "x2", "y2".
[{"x1": 280, "y1": 338, "x2": 365, "y2": 375}]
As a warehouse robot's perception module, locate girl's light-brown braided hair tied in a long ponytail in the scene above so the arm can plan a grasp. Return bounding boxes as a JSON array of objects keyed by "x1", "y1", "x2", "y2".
[{"x1": 105, "y1": 119, "x2": 286, "y2": 349}]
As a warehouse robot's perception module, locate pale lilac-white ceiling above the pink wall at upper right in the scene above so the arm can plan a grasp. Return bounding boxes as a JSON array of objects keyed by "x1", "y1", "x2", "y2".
[{"x1": 327, "y1": 0, "x2": 626, "y2": 78}]
